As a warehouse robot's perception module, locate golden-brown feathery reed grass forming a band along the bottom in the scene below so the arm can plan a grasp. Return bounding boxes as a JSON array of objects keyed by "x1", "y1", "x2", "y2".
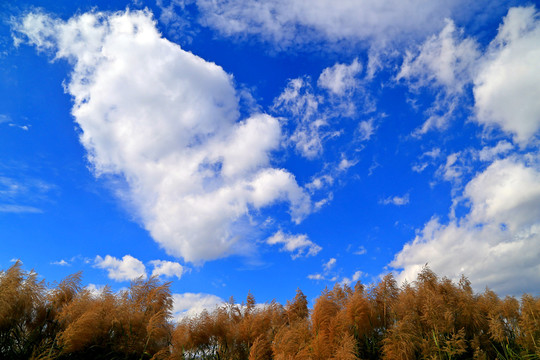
[{"x1": 0, "y1": 262, "x2": 540, "y2": 360}]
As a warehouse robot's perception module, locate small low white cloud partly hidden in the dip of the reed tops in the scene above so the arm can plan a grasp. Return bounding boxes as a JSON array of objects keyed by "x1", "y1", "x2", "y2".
[{"x1": 172, "y1": 293, "x2": 225, "y2": 321}]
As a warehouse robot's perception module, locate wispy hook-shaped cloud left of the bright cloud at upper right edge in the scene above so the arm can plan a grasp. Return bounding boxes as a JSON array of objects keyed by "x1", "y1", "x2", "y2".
[{"x1": 396, "y1": 20, "x2": 479, "y2": 135}]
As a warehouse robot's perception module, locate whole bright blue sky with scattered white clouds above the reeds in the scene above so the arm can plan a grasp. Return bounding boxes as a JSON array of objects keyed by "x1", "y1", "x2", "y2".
[{"x1": 0, "y1": 0, "x2": 540, "y2": 312}]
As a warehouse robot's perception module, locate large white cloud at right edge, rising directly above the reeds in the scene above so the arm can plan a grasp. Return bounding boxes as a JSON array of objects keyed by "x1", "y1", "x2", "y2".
[{"x1": 390, "y1": 158, "x2": 540, "y2": 295}]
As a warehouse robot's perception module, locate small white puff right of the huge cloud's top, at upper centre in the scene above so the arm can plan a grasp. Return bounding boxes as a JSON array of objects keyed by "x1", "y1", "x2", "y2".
[{"x1": 317, "y1": 59, "x2": 362, "y2": 96}]
